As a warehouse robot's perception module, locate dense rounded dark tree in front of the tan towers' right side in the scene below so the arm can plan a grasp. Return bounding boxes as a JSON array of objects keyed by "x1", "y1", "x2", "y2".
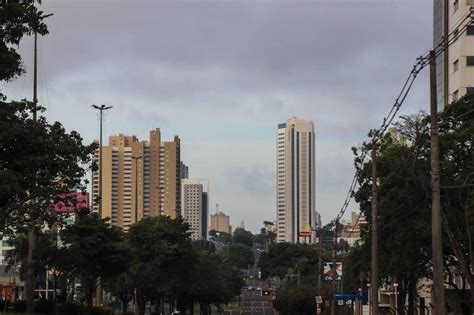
[{"x1": 128, "y1": 216, "x2": 196, "y2": 314}]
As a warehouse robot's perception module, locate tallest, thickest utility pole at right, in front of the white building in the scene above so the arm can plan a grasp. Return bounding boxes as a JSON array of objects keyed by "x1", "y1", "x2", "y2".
[{"x1": 430, "y1": 50, "x2": 445, "y2": 315}]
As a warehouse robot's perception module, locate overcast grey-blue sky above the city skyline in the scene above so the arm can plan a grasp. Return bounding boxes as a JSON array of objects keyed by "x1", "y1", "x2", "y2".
[{"x1": 2, "y1": 0, "x2": 432, "y2": 231}]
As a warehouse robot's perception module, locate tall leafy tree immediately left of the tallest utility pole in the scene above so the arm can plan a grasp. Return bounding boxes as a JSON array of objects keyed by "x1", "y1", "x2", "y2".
[{"x1": 351, "y1": 113, "x2": 431, "y2": 310}]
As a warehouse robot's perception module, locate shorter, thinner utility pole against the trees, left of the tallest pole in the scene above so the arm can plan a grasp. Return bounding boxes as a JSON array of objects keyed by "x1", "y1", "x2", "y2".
[{"x1": 370, "y1": 141, "x2": 379, "y2": 315}]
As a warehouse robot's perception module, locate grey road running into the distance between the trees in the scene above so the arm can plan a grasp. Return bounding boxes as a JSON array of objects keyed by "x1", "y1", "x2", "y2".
[{"x1": 224, "y1": 251, "x2": 273, "y2": 315}]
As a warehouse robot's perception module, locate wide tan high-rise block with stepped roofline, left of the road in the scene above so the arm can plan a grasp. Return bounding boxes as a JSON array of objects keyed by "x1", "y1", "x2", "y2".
[{"x1": 92, "y1": 128, "x2": 181, "y2": 230}]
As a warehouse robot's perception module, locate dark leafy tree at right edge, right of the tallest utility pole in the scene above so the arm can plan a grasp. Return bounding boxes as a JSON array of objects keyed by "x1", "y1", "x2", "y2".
[{"x1": 439, "y1": 94, "x2": 474, "y2": 313}]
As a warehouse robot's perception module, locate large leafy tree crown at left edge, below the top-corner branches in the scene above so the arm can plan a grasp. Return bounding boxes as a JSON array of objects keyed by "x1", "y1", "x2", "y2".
[{"x1": 0, "y1": 101, "x2": 95, "y2": 233}]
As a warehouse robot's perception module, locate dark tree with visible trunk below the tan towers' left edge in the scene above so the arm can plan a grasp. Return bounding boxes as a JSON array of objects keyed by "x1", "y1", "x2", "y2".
[{"x1": 60, "y1": 212, "x2": 129, "y2": 308}]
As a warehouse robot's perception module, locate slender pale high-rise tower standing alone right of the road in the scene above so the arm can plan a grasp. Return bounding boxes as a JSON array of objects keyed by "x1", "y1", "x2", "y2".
[{"x1": 276, "y1": 118, "x2": 317, "y2": 243}]
